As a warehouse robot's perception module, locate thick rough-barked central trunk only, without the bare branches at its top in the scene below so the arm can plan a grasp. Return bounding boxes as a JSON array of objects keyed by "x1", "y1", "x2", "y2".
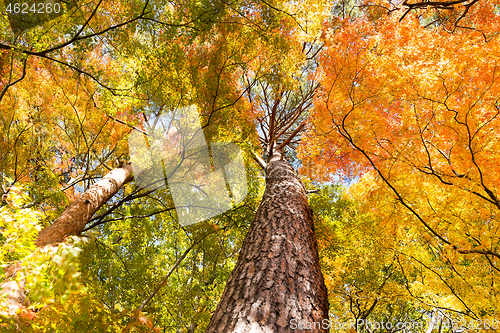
[{"x1": 206, "y1": 154, "x2": 328, "y2": 333}]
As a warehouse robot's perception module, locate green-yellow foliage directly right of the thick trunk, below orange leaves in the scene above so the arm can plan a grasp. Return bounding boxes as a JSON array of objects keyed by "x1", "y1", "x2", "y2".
[{"x1": 310, "y1": 185, "x2": 427, "y2": 332}]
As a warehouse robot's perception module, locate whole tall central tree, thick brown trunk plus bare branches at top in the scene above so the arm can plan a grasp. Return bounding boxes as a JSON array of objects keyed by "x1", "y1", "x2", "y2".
[{"x1": 206, "y1": 79, "x2": 328, "y2": 332}]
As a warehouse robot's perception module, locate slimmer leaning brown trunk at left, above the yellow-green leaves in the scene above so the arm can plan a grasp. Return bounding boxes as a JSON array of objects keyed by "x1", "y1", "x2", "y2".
[{"x1": 36, "y1": 164, "x2": 133, "y2": 247}]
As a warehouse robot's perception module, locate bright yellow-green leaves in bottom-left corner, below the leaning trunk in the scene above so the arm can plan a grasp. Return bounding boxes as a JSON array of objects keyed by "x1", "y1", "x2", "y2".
[{"x1": 0, "y1": 187, "x2": 158, "y2": 333}]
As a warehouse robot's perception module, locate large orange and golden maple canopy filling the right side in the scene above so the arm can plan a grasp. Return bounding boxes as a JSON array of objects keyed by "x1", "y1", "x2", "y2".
[{"x1": 301, "y1": 2, "x2": 500, "y2": 330}]
